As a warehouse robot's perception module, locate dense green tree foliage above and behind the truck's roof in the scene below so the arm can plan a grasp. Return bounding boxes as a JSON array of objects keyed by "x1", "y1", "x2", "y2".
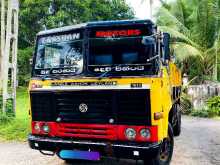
[{"x1": 19, "y1": 0, "x2": 134, "y2": 48}]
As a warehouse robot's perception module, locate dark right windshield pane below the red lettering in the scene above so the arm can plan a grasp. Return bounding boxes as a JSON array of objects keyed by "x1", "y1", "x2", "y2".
[{"x1": 89, "y1": 36, "x2": 156, "y2": 74}]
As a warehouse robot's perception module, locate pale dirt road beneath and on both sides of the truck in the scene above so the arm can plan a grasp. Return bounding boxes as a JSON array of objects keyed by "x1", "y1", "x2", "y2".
[{"x1": 0, "y1": 117, "x2": 220, "y2": 165}]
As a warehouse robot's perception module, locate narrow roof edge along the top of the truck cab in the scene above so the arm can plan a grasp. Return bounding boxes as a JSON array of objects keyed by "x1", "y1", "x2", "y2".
[{"x1": 37, "y1": 20, "x2": 154, "y2": 35}]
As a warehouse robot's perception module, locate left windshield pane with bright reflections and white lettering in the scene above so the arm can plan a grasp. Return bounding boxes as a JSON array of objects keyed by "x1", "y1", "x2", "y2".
[{"x1": 34, "y1": 34, "x2": 83, "y2": 75}]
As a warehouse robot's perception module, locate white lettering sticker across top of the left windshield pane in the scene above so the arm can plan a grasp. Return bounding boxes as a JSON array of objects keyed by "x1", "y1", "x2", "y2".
[{"x1": 39, "y1": 33, "x2": 80, "y2": 44}]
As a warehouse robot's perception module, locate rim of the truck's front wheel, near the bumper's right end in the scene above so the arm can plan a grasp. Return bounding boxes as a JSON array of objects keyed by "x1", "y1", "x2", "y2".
[{"x1": 160, "y1": 136, "x2": 172, "y2": 162}]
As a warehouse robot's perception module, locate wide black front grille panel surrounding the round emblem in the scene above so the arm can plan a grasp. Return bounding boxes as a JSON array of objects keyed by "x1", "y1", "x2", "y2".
[{"x1": 31, "y1": 90, "x2": 150, "y2": 125}]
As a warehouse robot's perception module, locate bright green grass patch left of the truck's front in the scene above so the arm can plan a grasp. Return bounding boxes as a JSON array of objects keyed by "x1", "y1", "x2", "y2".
[{"x1": 0, "y1": 88, "x2": 30, "y2": 141}]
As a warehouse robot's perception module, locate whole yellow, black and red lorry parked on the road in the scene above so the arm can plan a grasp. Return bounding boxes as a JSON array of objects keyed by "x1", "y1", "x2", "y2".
[{"x1": 28, "y1": 20, "x2": 182, "y2": 165}]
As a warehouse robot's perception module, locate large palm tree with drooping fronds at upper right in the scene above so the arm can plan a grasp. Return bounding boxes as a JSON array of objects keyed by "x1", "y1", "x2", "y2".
[{"x1": 156, "y1": 0, "x2": 220, "y2": 80}]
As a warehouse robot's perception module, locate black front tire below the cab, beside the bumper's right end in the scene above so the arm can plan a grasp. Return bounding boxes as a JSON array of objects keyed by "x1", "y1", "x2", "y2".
[{"x1": 144, "y1": 124, "x2": 174, "y2": 165}]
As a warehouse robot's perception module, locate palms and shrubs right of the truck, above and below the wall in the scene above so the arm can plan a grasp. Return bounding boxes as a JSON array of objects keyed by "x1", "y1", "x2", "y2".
[{"x1": 155, "y1": 0, "x2": 220, "y2": 117}]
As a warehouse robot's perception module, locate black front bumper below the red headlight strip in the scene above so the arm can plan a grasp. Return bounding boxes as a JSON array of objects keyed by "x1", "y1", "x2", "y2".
[{"x1": 28, "y1": 135, "x2": 161, "y2": 159}]
